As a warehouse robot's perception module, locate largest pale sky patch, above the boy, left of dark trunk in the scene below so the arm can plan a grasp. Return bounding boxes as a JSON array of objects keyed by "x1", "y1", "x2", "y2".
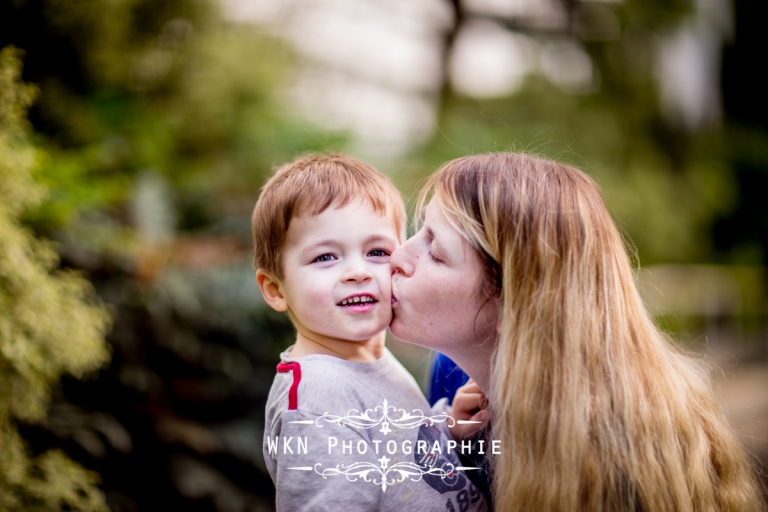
[{"x1": 221, "y1": 0, "x2": 453, "y2": 159}]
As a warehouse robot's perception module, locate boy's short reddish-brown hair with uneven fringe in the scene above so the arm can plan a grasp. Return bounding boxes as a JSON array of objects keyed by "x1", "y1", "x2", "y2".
[{"x1": 251, "y1": 154, "x2": 406, "y2": 279}]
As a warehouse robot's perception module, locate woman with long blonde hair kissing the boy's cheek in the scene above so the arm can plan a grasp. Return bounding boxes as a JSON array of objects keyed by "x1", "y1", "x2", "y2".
[{"x1": 391, "y1": 153, "x2": 761, "y2": 511}]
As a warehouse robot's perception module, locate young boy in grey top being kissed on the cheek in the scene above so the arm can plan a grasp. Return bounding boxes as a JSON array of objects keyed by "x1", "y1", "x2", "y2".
[{"x1": 252, "y1": 155, "x2": 490, "y2": 511}]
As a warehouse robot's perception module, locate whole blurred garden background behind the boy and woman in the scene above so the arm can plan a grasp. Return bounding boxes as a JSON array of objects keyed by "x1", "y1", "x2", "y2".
[{"x1": 0, "y1": 0, "x2": 768, "y2": 512}]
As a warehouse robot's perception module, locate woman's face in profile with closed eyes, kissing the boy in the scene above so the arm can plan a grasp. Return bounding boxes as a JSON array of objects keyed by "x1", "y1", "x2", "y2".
[{"x1": 390, "y1": 203, "x2": 496, "y2": 355}]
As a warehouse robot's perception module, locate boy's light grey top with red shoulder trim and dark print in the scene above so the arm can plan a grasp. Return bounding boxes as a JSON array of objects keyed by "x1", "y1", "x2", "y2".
[{"x1": 262, "y1": 348, "x2": 488, "y2": 512}]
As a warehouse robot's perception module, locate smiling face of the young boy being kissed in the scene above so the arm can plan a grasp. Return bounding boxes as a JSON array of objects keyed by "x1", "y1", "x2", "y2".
[{"x1": 280, "y1": 200, "x2": 399, "y2": 342}]
